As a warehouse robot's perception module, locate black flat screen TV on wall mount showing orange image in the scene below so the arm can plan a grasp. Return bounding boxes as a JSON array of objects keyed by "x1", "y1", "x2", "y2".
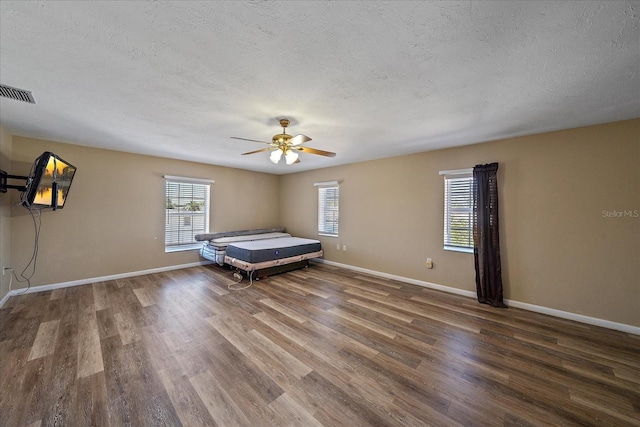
[{"x1": 22, "y1": 151, "x2": 76, "y2": 210}]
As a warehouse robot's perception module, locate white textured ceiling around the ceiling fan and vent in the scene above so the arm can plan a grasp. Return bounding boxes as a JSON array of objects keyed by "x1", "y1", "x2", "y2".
[{"x1": 0, "y1": 0, "x2": 640, "y2": 174}]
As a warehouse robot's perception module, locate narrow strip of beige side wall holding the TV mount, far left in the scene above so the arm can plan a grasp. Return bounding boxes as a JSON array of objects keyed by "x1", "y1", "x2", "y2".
[{"x1": 0, "y1": 126, "x2": 15, "y2": 300}]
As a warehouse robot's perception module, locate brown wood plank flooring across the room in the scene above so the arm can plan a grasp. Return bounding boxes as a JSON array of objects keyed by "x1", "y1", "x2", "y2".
[{"x1": 0, "y1": 264, "x2": 640, "y2": 426}]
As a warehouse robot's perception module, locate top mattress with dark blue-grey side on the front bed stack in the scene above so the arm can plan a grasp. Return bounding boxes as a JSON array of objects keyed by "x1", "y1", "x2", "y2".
[{"x1": 225, "y1": 237, "x2": 322, "y2": 264}]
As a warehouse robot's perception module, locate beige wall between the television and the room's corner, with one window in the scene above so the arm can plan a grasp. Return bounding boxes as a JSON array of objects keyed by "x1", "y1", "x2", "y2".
[{"x1": 9, "y1": 136, "x2": 281, "y2": 286}]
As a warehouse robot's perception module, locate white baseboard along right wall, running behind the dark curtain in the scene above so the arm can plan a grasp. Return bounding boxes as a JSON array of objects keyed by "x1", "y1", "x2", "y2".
[{"x1": 313, "y1": 258, "x2": 640, "y2": 335}]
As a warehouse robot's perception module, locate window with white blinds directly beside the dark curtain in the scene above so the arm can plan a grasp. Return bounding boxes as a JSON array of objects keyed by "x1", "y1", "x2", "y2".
[{"x1": 440, "y1": 169, "x2": 473, "y2": 252}]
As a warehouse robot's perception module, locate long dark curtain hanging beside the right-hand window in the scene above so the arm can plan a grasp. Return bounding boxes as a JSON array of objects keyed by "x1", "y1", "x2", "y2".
[{"x1": 473, "y1": 163, "x2": 506, "y2": 307}]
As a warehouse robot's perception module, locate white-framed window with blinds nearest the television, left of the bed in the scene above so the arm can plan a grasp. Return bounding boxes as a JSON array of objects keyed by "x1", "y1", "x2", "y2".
[{"x1": 164, "y1": 176, "x2": 213, "y2": 252}]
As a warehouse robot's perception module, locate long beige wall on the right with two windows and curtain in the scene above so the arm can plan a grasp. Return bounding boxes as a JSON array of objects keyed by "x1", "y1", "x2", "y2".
[{"x1": 280, "y1": 120, "x2": 640, "y2": 326}]
